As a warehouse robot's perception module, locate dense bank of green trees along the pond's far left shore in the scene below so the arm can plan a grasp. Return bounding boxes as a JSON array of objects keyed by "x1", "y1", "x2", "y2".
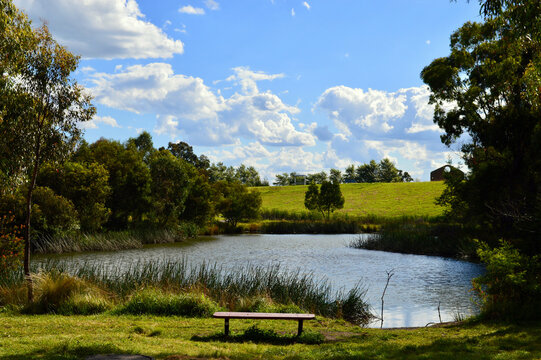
[{"x1": 0, "y1": 132, "x2": 265, "y2": 236}]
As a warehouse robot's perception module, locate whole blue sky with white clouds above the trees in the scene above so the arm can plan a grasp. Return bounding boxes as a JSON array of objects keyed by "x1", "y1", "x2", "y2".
[{"x1": 14, "y1": 0, "x2": 481, "y2": 183}]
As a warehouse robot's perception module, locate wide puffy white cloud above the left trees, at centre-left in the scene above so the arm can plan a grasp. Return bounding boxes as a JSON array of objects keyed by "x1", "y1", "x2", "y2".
[{"x1": 90, "y1": 63, "x2": 315, "y2": 146}]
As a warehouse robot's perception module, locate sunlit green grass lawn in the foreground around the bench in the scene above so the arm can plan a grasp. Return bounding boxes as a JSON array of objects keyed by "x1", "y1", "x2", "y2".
[{"x1": 0, "y1": 314, "x2": 541, "y2": 360}]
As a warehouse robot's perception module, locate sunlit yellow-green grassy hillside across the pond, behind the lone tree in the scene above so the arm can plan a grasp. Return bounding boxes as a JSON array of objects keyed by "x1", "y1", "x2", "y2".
[{"x1": 254, "y1": 181, "x2": 444, "y2": 218}]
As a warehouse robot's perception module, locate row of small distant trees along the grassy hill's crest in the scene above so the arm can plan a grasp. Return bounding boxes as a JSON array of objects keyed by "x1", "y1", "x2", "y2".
[{"x1": 273, "y1": 158, "x2": 413, "y2": 186}]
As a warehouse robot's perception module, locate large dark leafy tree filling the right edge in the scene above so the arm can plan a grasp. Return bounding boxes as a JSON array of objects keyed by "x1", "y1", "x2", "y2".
[{"x1": 421, "y1": 0, "x2": 541, "y2": 253}]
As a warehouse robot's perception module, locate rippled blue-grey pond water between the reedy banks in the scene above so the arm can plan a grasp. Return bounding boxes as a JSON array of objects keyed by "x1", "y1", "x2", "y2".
[{"x1": 40, "y1": 234, "x2": 483, "y2": 327}]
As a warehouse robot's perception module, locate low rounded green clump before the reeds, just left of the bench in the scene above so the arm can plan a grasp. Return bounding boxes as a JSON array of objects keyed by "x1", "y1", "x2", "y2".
[{"x1": 116, "y1": 289, "x2": 219, "y2": 317}]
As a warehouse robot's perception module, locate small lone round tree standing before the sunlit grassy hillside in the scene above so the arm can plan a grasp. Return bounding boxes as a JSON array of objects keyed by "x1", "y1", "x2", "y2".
[{"x1": 304, "y1": 181, "x2": 344, "y2": 220}]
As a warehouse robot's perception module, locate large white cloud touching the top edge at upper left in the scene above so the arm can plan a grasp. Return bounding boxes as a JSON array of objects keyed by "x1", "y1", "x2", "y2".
[{"x1": 14, "y1": 0, "x2": 183, "y2": 59}]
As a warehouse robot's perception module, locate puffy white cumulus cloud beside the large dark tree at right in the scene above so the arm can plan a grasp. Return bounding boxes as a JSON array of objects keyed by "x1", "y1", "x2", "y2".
[{"x1": 315, "y1": 86, "x2": 459, "y2": 177}]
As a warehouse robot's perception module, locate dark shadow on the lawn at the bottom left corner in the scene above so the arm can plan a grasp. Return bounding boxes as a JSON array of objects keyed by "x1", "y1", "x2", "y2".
[{"x1": 0, "y1": 343, "x2": 126, "y2": 360}]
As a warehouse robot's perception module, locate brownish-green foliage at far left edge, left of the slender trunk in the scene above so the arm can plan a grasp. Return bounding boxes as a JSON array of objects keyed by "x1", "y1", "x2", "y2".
[{"x1": 0, "y1": 213, "x2": 24, "y2": 277}]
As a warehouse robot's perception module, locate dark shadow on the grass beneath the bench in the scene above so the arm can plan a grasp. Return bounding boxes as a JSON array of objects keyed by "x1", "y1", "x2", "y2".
[{"x1": 191, "y1": 326, "x2": 325, "y2": 345}]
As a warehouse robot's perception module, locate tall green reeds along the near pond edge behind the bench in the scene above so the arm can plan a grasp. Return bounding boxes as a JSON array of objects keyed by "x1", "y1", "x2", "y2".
[{"x1": 0, "y1": 259, "x2": 372, "y2": 325}]
